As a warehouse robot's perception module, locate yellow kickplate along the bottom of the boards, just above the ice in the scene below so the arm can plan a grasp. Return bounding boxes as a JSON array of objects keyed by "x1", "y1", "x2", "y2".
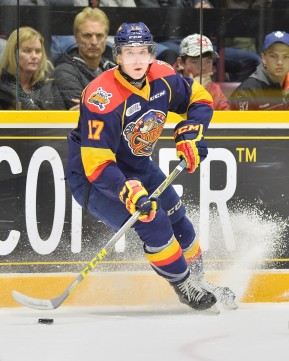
[{"x1": 0, "y1": 271, "x2": 289, "y2": 307}]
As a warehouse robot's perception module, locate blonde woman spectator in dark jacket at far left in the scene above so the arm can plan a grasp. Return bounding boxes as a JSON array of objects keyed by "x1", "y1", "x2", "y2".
[{"x1": 0, "y1": 27, "x2": 63, "y2": 110}]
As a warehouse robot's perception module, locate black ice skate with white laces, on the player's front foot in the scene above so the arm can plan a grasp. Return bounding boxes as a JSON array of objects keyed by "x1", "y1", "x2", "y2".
[{"x1": 172, "y1": 275, "x2": 217, "y2": 311}]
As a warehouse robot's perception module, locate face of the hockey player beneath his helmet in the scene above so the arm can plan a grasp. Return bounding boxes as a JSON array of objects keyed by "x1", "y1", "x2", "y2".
[{"x1": 117, "y1": 46, "x2": 152, "y2": 79}]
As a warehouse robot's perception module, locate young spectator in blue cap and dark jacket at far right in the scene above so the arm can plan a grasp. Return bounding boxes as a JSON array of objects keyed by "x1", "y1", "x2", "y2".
[{"x1": 230, "y1": 31, "x2": 289, "y2": 110}]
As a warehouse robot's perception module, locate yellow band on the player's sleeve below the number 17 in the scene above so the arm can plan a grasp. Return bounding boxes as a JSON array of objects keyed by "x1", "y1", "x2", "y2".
[{"x1": 81, "y1": 147, "x2": 116, "y2": 178}]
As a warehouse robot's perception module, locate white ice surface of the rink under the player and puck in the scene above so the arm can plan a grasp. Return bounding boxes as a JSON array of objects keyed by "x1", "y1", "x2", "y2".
[{"x1": 0, "y1": 303, "x2": 289, "y2": 361}]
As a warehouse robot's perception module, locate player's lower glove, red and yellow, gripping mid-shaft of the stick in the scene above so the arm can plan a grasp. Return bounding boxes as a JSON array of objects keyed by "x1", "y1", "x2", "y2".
[{"x1": 119, "y1": 179, "x2": 159, "y2": 222}]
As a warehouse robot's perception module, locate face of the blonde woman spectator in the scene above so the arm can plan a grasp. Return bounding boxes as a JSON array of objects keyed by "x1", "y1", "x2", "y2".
[{"x1": 19, "y1": 39, "x2": 42, "y2": 73}]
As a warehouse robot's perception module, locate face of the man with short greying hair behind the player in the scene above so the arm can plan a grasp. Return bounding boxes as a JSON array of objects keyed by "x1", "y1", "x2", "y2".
[{"x1": 75, "y1": 19, "x2": 107, "y2": 60}]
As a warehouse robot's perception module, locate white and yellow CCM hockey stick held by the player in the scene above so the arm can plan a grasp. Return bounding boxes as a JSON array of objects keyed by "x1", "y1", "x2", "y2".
[{"x1": 12, "y1": 160, "x2": 186, "y2": 310}]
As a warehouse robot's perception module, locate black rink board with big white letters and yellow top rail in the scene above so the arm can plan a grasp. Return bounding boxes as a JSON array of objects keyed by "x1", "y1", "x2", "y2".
[{"x1": 0, "y1": 111, "x2": 289, "y2": 274}]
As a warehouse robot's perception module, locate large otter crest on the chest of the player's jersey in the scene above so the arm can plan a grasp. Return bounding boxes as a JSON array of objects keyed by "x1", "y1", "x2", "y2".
[{"x1": 123, "y1": 110, "x2": 166, "y2": 156}]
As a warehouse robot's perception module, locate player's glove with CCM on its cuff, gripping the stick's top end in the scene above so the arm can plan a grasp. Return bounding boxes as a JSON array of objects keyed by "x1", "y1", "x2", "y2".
[{"x1": 174, "y1": 120, "x2": 208, "y2": 173}]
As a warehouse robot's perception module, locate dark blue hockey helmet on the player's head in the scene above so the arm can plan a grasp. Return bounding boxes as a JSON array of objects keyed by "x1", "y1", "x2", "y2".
[{"x1": 112, "y1": 22, "x2": 156, "y2": 61}]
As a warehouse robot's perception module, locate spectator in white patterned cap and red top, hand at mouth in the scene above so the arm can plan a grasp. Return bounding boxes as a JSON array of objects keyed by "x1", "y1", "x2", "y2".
[{"x1": 176, "y1": 34, "x2": 230, "y2": 110}]
